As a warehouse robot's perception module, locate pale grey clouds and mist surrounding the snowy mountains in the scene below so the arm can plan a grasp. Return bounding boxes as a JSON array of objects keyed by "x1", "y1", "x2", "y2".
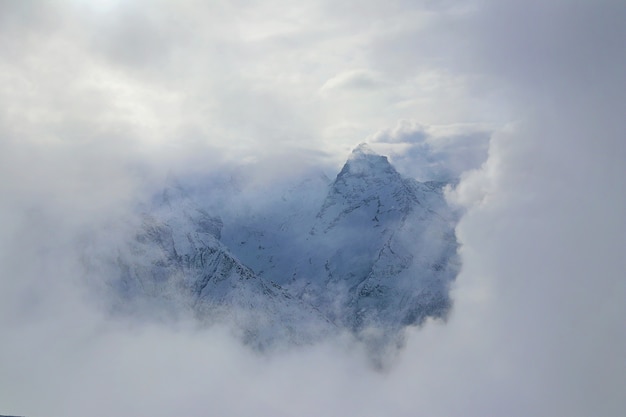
[{"x1": 0, "y1": 0, "x2": 626, "y2": 417}]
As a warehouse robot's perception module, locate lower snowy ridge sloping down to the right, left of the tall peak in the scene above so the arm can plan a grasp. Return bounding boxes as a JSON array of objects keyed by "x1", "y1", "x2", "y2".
[{"x1": 112, "y1": 180, "x2": 334, "y2": 348}]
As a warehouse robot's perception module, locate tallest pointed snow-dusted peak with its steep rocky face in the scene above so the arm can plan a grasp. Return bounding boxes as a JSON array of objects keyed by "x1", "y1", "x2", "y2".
[{"x1": 294, "y1": 145, "x2": 458, "y2": 330}]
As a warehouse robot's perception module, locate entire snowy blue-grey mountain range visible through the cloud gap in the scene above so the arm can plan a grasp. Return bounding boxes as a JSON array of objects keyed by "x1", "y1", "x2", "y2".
[{"x1": 102, "y1": 144, "x2": 459, "y2": 348}]
